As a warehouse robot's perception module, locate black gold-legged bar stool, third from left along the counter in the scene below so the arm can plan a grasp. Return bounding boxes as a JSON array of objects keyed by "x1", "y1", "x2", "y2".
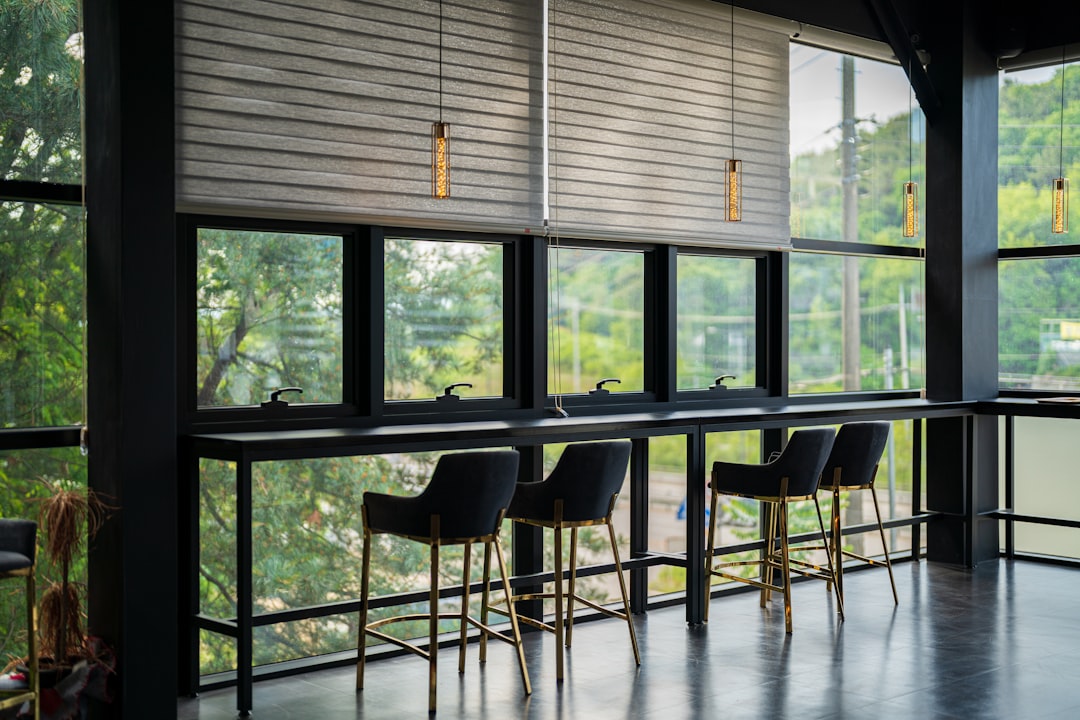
[{"x1": 705, "y1": 427, "x2": 843, "y2": 633}]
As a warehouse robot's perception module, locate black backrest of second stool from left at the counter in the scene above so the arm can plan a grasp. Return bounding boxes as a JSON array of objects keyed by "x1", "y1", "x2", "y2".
[{"x1": 544, "y1": 440, "x2": 632, "y2": 521}]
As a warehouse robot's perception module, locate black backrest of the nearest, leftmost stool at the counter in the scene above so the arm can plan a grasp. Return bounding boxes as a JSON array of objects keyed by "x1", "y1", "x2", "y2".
[{"x1": 419, "y1": 450, "x2": 519, "y2": 538}]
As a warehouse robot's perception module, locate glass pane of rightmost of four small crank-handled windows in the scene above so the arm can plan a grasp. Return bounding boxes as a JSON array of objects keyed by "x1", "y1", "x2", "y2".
[{"x1": 676, "y1": 255, "x2": 757, "y2": 390}]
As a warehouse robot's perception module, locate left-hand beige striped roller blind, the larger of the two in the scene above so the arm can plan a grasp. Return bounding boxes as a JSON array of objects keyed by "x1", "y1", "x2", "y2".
[{"x1": 176, "y1": 0, "x2": 543, "y2": 231}]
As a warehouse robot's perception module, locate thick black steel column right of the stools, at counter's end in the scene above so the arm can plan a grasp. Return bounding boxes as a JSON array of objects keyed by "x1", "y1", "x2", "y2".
[{"x1": 924, "y1": 0, "x2": 998, "y2": 566}]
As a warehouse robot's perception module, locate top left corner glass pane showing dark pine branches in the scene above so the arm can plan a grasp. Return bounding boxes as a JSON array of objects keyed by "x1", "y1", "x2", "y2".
[{"x1": 0, "y1": 0, "x2": 82, "y2": 185}]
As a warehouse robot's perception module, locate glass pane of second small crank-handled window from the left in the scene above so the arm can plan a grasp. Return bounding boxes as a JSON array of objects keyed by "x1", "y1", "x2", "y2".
[{"x1": 386, "y1": 237, "x2": 505, "y2": 400}]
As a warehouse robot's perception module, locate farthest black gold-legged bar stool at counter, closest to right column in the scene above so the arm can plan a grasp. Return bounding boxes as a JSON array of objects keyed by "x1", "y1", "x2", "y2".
[{"x1": 819, "y1": 421, "x2": 900, "y2": 604}]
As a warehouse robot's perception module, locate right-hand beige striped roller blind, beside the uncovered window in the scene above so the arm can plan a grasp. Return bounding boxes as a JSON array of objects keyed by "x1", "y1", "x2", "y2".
[{"x1": 549, "y1": 0, "x2": 789, "y2": 247}]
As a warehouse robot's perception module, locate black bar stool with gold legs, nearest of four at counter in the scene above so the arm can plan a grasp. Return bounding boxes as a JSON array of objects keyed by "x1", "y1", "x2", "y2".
[{"x1": 356, "y1": 450, "x2": 532, "y2": 712}]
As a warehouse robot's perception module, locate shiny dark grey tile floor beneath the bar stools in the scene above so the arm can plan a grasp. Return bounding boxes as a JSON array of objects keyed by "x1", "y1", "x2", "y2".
[{"x1": 177, "y1": 560, "x2": 1080, "y2": 720}]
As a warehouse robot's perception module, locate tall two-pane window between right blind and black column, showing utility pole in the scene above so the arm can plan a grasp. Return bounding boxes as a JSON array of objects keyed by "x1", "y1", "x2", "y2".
[{"x1": 787, "y1": 44, "x2": 924, "y2": 394}]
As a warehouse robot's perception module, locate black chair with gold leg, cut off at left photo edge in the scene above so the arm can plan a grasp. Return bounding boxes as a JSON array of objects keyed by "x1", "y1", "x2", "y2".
[{"x1": 0, "y1": 519, "x2": 41, "y2": 720}]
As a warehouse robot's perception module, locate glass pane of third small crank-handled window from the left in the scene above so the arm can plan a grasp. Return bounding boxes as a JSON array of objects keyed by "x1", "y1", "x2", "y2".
[{"x1": 548, "y1": 247, "x2": 645, "y2": 395}]
